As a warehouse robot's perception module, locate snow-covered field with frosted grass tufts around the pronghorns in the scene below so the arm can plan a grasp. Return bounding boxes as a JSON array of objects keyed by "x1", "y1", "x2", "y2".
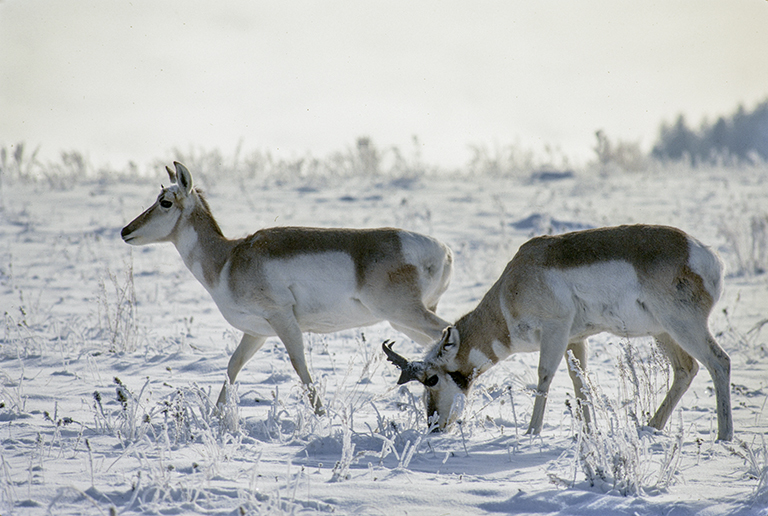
[{"x1": 0, "y1": 154, "x2": 768, "y2": 516}]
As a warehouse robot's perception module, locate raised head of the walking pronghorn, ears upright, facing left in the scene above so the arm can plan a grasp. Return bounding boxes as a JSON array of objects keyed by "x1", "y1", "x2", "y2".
[{"x1": 120, "y1": 162, "x2": 193, "y2": 245}]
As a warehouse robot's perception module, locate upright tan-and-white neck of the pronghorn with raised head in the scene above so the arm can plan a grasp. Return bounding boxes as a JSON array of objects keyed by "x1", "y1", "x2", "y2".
[{"x1": 172, "y1": 190, "x2": 232, "y2": 289}]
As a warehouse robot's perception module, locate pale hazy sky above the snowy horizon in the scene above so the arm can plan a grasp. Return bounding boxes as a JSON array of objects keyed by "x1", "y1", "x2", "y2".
[{"x1": 0, "y1": 0, "x2": 768, "y2": 167}]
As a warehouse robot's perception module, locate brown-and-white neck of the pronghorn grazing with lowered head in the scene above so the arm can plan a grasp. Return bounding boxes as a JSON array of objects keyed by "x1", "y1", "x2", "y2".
[{"x1": 456, "y1": 288, "x2": 511, "y2": 378}]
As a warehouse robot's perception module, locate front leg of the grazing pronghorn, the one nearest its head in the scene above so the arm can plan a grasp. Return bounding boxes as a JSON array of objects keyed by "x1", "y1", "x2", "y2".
[{"x1": 525, "y1": 321, "x2": 570, "y2": 435}]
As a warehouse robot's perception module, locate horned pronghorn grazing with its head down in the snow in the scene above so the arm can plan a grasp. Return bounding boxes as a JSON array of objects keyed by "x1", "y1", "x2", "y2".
[{"x1": 383, "y1": 225, "x2": 733, "y2": 441}]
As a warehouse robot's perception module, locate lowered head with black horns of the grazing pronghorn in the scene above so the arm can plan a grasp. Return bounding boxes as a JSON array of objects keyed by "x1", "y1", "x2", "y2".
[{"x1": 382, "y1": 326, "x2": 473, "y2": 430}]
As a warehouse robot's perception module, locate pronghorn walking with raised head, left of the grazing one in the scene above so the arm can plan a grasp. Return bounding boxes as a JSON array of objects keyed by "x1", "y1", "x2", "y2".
[{"x1": 121, "y1": 163, "x2": 453, "y2": 412}]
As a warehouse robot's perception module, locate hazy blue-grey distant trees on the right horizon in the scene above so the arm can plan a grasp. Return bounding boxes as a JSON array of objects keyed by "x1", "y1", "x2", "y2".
[{"x1": 651, "y1": 100, "x2": 768, "y2": 165}]
